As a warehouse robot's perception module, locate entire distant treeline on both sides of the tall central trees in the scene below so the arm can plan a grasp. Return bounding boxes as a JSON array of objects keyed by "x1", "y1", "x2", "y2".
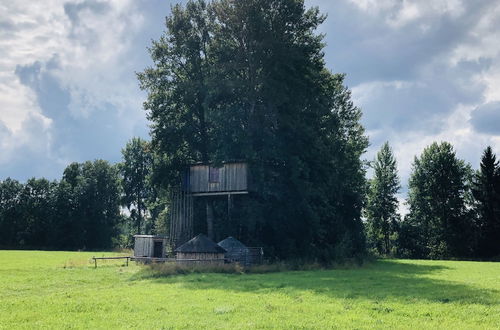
[{"x1": 0, "y1": 138, "x2": 500, "y2": 259}]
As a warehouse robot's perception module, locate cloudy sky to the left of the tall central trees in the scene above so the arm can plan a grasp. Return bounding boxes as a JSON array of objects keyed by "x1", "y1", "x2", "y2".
[{"x1": 0, "y1": 0, "x2": 168, "y2": 179}]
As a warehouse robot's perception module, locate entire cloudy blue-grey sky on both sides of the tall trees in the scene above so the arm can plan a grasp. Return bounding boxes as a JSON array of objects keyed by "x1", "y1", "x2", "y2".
[{"x1": 0, "y1": 0, "x2": 500, "y2": 208}]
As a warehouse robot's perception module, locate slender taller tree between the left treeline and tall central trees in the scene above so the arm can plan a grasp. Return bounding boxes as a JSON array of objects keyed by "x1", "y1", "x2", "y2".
[{"x1": 120, "y1": 138, "x2": 153, "y2": 234}]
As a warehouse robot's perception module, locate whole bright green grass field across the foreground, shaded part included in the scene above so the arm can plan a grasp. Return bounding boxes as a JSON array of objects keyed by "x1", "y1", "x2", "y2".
[{"x1": 0, "y1": 251, "x2": 500, "y2": 329}]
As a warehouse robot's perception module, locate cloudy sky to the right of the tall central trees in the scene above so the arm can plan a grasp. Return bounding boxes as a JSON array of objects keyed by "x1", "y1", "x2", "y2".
[{"x1": 307, "y1": 0, "x2": 500, "y2": 187}]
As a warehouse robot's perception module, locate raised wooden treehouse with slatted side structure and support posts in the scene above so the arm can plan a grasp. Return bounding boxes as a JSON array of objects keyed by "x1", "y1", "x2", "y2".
[{"x1": 170, "y1": 162, "x2": 250, "y2": 249}]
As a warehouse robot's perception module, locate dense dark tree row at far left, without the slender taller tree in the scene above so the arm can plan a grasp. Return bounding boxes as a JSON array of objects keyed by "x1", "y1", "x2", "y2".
[{"x1": 0, "y1": 160, "x2": 121, "y2": 249}]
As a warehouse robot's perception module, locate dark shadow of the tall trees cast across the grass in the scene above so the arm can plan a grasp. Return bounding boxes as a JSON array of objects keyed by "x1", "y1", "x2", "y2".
[{"x1": 127, "y1": 260, "x2": 500, "y2": 305}]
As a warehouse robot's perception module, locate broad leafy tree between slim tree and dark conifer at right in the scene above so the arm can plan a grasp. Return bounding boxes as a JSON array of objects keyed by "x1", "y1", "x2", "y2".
[{"x1": 400, "y1": 142, "x2": 473, "y2": 258}]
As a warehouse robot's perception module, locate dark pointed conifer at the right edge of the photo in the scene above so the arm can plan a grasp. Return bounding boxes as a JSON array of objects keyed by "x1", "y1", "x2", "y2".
[{"x1": 472, "y1": 147, "x2": 500, "y2": 257}]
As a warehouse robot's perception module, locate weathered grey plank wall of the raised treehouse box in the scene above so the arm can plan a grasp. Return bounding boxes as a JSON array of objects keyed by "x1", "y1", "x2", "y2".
[{"x1": 187, "y1": 163, "x2": 248, "y2": 193}]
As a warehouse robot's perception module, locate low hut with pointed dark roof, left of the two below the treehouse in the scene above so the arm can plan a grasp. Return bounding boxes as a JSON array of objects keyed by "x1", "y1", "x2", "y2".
[{"x1": 175, "y1": 234, "x2": 226, "y2": 264}]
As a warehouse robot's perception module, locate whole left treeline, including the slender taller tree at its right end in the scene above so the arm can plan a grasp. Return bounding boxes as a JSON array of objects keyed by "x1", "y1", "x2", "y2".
[{"x1": 0, "y1": 138, "x2": 166, "y2": 250}]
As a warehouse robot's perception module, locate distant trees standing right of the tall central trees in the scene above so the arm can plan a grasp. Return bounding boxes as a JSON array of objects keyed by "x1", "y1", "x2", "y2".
[{"x1": 364, "y1": 142, "x2": 500, "y2": 259}]
